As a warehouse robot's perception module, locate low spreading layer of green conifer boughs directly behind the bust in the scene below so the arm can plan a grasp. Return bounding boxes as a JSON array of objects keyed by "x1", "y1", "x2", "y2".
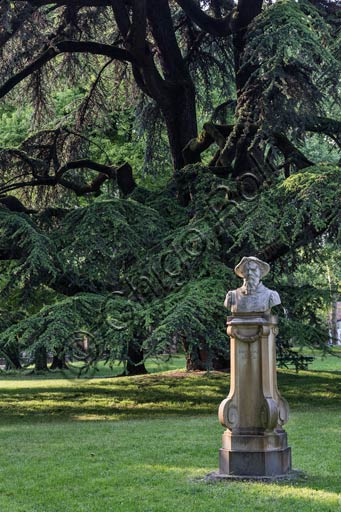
[{"x1": 0, "y1": 165, "x2": 340, "y2": 372}]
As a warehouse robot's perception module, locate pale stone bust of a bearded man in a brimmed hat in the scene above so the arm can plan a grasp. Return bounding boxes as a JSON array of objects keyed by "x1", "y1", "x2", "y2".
[{"x1": 224, "y1": 256, "x2": 281, "y2": 313}]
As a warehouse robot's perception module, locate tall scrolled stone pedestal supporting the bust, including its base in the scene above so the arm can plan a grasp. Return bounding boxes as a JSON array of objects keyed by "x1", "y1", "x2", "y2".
[{"x1": 219, "y1": 312, "x2": 291, "y2": 477}]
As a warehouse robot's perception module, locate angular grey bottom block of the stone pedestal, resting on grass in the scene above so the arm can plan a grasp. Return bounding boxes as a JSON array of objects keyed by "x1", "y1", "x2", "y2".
[{"x1": 219, "y1": 447, "x2": 291, "y2": 477}]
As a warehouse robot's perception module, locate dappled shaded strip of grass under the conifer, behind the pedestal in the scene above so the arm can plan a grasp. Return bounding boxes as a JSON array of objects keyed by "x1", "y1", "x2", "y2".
[{"x1": 0, "y1": 371, "x2": 341, "y2": 421}]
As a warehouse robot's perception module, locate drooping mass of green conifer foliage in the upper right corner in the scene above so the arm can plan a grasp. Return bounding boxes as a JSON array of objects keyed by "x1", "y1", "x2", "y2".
[{"x1": 237, "y1": 0, "x2": 341, "y2": 148}]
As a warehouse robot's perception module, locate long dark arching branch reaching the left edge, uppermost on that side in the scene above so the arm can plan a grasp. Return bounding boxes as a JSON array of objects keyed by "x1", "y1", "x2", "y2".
[{"x1": 0, "y1": 41, "x2": 133, "y2": 98}]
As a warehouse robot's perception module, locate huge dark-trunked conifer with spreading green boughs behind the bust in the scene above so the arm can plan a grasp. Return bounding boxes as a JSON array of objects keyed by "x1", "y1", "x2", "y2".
[{"x1": 0, "y1": 0, "x2": 340, "y2": 372}]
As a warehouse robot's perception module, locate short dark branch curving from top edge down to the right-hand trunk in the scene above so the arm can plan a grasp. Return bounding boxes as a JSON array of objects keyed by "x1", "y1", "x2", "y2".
[{"x1": 176, "y1": 0, "x2": 232, "y2": 37}]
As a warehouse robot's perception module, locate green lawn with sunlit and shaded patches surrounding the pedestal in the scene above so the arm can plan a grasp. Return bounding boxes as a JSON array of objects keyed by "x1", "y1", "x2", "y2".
[{"x1": 0, "y1": 356, "x2": 341, "y2": 512}]
